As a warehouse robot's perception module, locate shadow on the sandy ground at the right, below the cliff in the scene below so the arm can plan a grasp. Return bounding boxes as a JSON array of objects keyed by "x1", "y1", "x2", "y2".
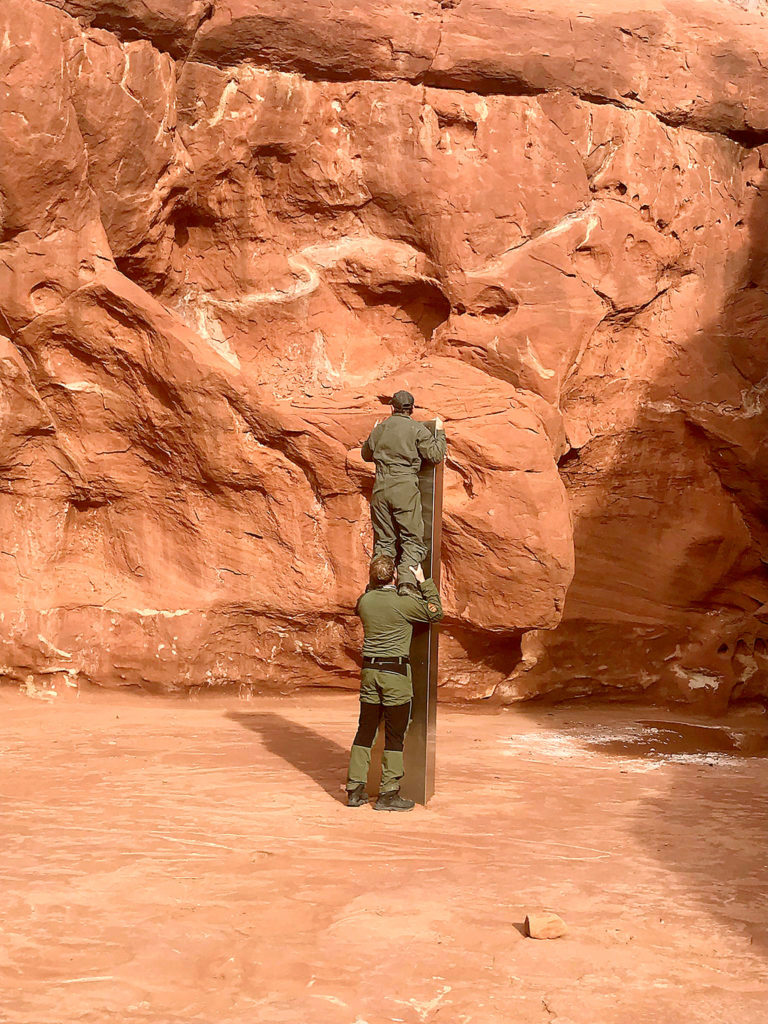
[{"x1": 515, "y1": 700, "x2": 768, "y2": 957}]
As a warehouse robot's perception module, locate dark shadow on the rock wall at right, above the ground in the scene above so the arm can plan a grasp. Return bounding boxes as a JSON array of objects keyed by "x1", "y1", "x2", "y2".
[{"x1": 518, "y1": 146, "x2": 768, "y2": 713}]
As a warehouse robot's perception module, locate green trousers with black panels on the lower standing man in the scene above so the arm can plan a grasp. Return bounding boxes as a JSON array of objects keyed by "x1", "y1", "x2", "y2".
[{"x1": 347, "y1": 666, "x2": 414, "y2": 793}]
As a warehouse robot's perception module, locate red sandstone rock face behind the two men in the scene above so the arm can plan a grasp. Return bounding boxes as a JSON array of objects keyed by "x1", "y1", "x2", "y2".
[{"x1": 0, "y1": 0, "x2": 768, "y2": 708}]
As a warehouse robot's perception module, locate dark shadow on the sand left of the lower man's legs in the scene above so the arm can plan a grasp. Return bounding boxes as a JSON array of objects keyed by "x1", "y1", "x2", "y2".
[{"x1": 226, "y1": 712, "x2": 349, "y2": 803}]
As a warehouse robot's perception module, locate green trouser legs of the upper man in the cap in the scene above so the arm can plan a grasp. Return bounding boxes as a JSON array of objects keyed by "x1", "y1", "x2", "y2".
[{"x1": 371, "y1": 473, "x2": 427, "y2": 583}]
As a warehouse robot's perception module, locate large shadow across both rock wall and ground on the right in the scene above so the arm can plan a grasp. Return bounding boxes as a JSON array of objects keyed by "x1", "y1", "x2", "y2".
[{"x1": 520, "y1": 134, "x2": 768, "y2": 956}]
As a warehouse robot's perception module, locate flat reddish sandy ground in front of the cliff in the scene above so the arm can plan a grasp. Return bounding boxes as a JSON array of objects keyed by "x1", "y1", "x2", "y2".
[{"x1": 0, "y1": 691, "x2": 768, "y2": 1024}]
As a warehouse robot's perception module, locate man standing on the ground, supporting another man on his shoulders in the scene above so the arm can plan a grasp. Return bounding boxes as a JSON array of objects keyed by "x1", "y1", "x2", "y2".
[{"x1": 347, "y1": 555, "x2": 442, "y2": 811}]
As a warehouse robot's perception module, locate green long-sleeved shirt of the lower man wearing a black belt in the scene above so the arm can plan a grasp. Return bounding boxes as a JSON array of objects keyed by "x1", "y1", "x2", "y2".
[{"x1": 357, "y1": 580, "x2": 442, "y2": 657}]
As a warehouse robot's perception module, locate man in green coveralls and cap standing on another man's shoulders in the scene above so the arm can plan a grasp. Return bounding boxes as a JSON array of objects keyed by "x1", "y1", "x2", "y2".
[{"x1": 361, "y1": 391, "x2": 445, "y2": 597}]
